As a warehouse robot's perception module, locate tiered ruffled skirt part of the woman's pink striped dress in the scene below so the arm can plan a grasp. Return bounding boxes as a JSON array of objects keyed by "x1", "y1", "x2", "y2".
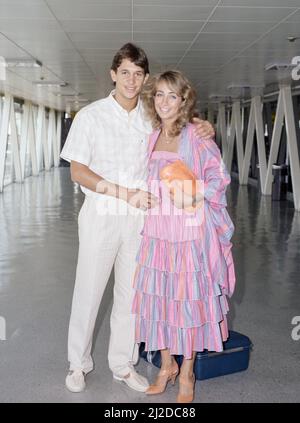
[{"x1": 132, "y1": 237, "x2": 228, "y2": 358}]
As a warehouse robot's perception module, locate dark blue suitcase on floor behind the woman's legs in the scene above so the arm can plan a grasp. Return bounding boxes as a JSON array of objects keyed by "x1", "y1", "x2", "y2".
[{"x1": 140, "y1": 331, "x2": 252, "y2": 380}]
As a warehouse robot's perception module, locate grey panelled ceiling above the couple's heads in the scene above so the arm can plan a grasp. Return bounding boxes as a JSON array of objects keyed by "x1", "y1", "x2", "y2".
[{"x1": 0, "y1": 0, "x2": 300, "y2": 107}]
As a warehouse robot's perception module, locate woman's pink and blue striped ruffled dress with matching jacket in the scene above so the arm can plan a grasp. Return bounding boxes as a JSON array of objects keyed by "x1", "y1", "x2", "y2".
[{"x1": 132, "y1": 124, "x2": 235, "y2": 358}]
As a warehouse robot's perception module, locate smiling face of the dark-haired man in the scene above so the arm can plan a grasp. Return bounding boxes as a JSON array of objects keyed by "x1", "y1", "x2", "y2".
[{"x1": 110, "y1": 59, "x2": 149, "y2": 100}]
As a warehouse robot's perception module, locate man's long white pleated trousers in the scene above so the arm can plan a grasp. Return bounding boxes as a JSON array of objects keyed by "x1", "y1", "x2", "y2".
[{"x1": 68, "y1": 197, "x2": 144, "y2": 377}]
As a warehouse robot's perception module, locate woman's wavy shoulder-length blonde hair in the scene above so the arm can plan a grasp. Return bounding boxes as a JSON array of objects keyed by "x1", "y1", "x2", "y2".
[{"x1": 141, "y1": 70, "x2": 198, "y2": 136}]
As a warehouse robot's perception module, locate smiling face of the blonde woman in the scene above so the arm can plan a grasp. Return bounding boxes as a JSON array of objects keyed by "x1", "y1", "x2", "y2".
[{"x1": 154, "y1": 81, "x2": 183, "y2": 122}]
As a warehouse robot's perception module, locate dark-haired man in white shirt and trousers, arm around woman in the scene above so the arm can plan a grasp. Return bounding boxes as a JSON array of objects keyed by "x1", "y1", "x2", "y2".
[{"x1": 61, "y1": 43, "x2": 214, "y2": 392}]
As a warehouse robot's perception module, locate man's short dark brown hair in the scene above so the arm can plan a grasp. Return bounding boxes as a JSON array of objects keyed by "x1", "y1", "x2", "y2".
[{"x1": 111, "y1": 43, "x2": 149, "y2": 75}]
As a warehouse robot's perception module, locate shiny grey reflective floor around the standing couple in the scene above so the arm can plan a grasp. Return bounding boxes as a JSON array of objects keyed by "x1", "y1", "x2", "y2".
[{"x1": 0, "y1": 168, "x2": 300, "y2": 403}]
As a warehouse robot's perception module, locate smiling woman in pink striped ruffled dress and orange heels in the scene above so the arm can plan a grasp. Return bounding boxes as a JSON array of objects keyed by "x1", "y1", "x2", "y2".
[{"x1": 133, "y1": 71, "x2": 235, "y2": 402}]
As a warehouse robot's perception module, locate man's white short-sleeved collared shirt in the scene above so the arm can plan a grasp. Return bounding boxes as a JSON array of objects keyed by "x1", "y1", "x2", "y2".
[{"x1": 60, "y1": 92, "x2": 152, "y2": 198}]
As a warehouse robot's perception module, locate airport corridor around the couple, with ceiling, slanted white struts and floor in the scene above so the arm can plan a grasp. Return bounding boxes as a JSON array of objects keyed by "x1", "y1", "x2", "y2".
[{"x1": 0, "y1": 0, "x2": 300, "y2": 404}]
